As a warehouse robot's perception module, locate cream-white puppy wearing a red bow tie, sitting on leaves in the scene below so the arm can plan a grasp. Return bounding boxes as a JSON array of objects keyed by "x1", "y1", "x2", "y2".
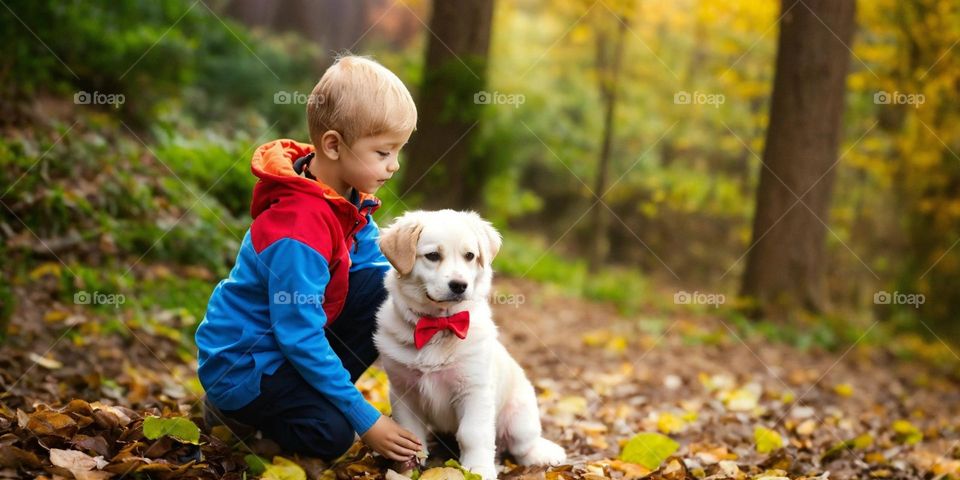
[{"x1": 374, "y1": 210, "x2": 566, "y2": 479}]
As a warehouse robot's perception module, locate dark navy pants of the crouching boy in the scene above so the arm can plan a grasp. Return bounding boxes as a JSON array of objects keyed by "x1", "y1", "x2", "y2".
[{"x1": 223, "y1": 269, "x2": 387, "y2": 460}]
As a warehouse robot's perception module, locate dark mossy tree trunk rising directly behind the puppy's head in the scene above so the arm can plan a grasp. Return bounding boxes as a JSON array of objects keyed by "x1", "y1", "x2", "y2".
[{"x1": 397, "y1": 0, "x2": 496, "y2": 209}]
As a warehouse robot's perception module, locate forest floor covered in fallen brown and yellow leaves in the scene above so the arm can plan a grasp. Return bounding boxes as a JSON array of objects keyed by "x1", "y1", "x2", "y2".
[{"x1": 0, "y1": 272, "x2": 960, "y2": 479}]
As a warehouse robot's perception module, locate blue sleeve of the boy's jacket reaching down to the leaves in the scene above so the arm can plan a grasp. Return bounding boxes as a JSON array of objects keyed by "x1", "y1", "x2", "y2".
[{"x1": 260, "y1": 238, "x2": 380, "y2": 436}]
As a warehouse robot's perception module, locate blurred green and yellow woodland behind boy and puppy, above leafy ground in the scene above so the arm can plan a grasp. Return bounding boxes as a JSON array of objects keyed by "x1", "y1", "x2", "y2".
[{"x1": 0, "y1": 0, "x2": 960, "y2": 339}]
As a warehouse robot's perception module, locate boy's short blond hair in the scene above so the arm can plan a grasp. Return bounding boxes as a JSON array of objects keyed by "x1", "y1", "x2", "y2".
[{"x1": 307, "y1": 55, "x2": 417, "y2": 148}]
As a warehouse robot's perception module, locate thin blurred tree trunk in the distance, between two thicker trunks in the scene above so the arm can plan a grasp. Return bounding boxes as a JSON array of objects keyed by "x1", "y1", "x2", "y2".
[{"x1": 588, "y1": 18, "x2": 627, "y2": 272}]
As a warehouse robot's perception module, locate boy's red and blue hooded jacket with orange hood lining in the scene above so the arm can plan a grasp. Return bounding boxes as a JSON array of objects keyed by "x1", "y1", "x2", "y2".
[{"x1": 196, "y1": 140, "x2": 389, "y2": 435}]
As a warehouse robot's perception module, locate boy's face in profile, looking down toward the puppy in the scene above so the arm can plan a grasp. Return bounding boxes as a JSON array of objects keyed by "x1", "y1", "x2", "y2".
[{"x1": 340, "y1": 132, "x2": 412, "y2": 194}]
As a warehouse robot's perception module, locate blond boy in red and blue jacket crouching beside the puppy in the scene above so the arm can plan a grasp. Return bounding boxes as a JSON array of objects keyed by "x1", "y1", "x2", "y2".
[{"x1": 196, "y1": 56, "x2": 422, "y2": 461}]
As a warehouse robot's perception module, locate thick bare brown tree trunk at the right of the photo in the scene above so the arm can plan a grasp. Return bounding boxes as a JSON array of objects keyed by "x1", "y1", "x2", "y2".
[{"x1": 742, "y1": 0, "x2": 856, "y2": 315}]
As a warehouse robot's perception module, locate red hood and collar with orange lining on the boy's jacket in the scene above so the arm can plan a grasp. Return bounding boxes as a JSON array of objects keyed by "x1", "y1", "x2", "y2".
[{"x1": 250, "y1": 139, "x2": 380, "y2": 218}]
